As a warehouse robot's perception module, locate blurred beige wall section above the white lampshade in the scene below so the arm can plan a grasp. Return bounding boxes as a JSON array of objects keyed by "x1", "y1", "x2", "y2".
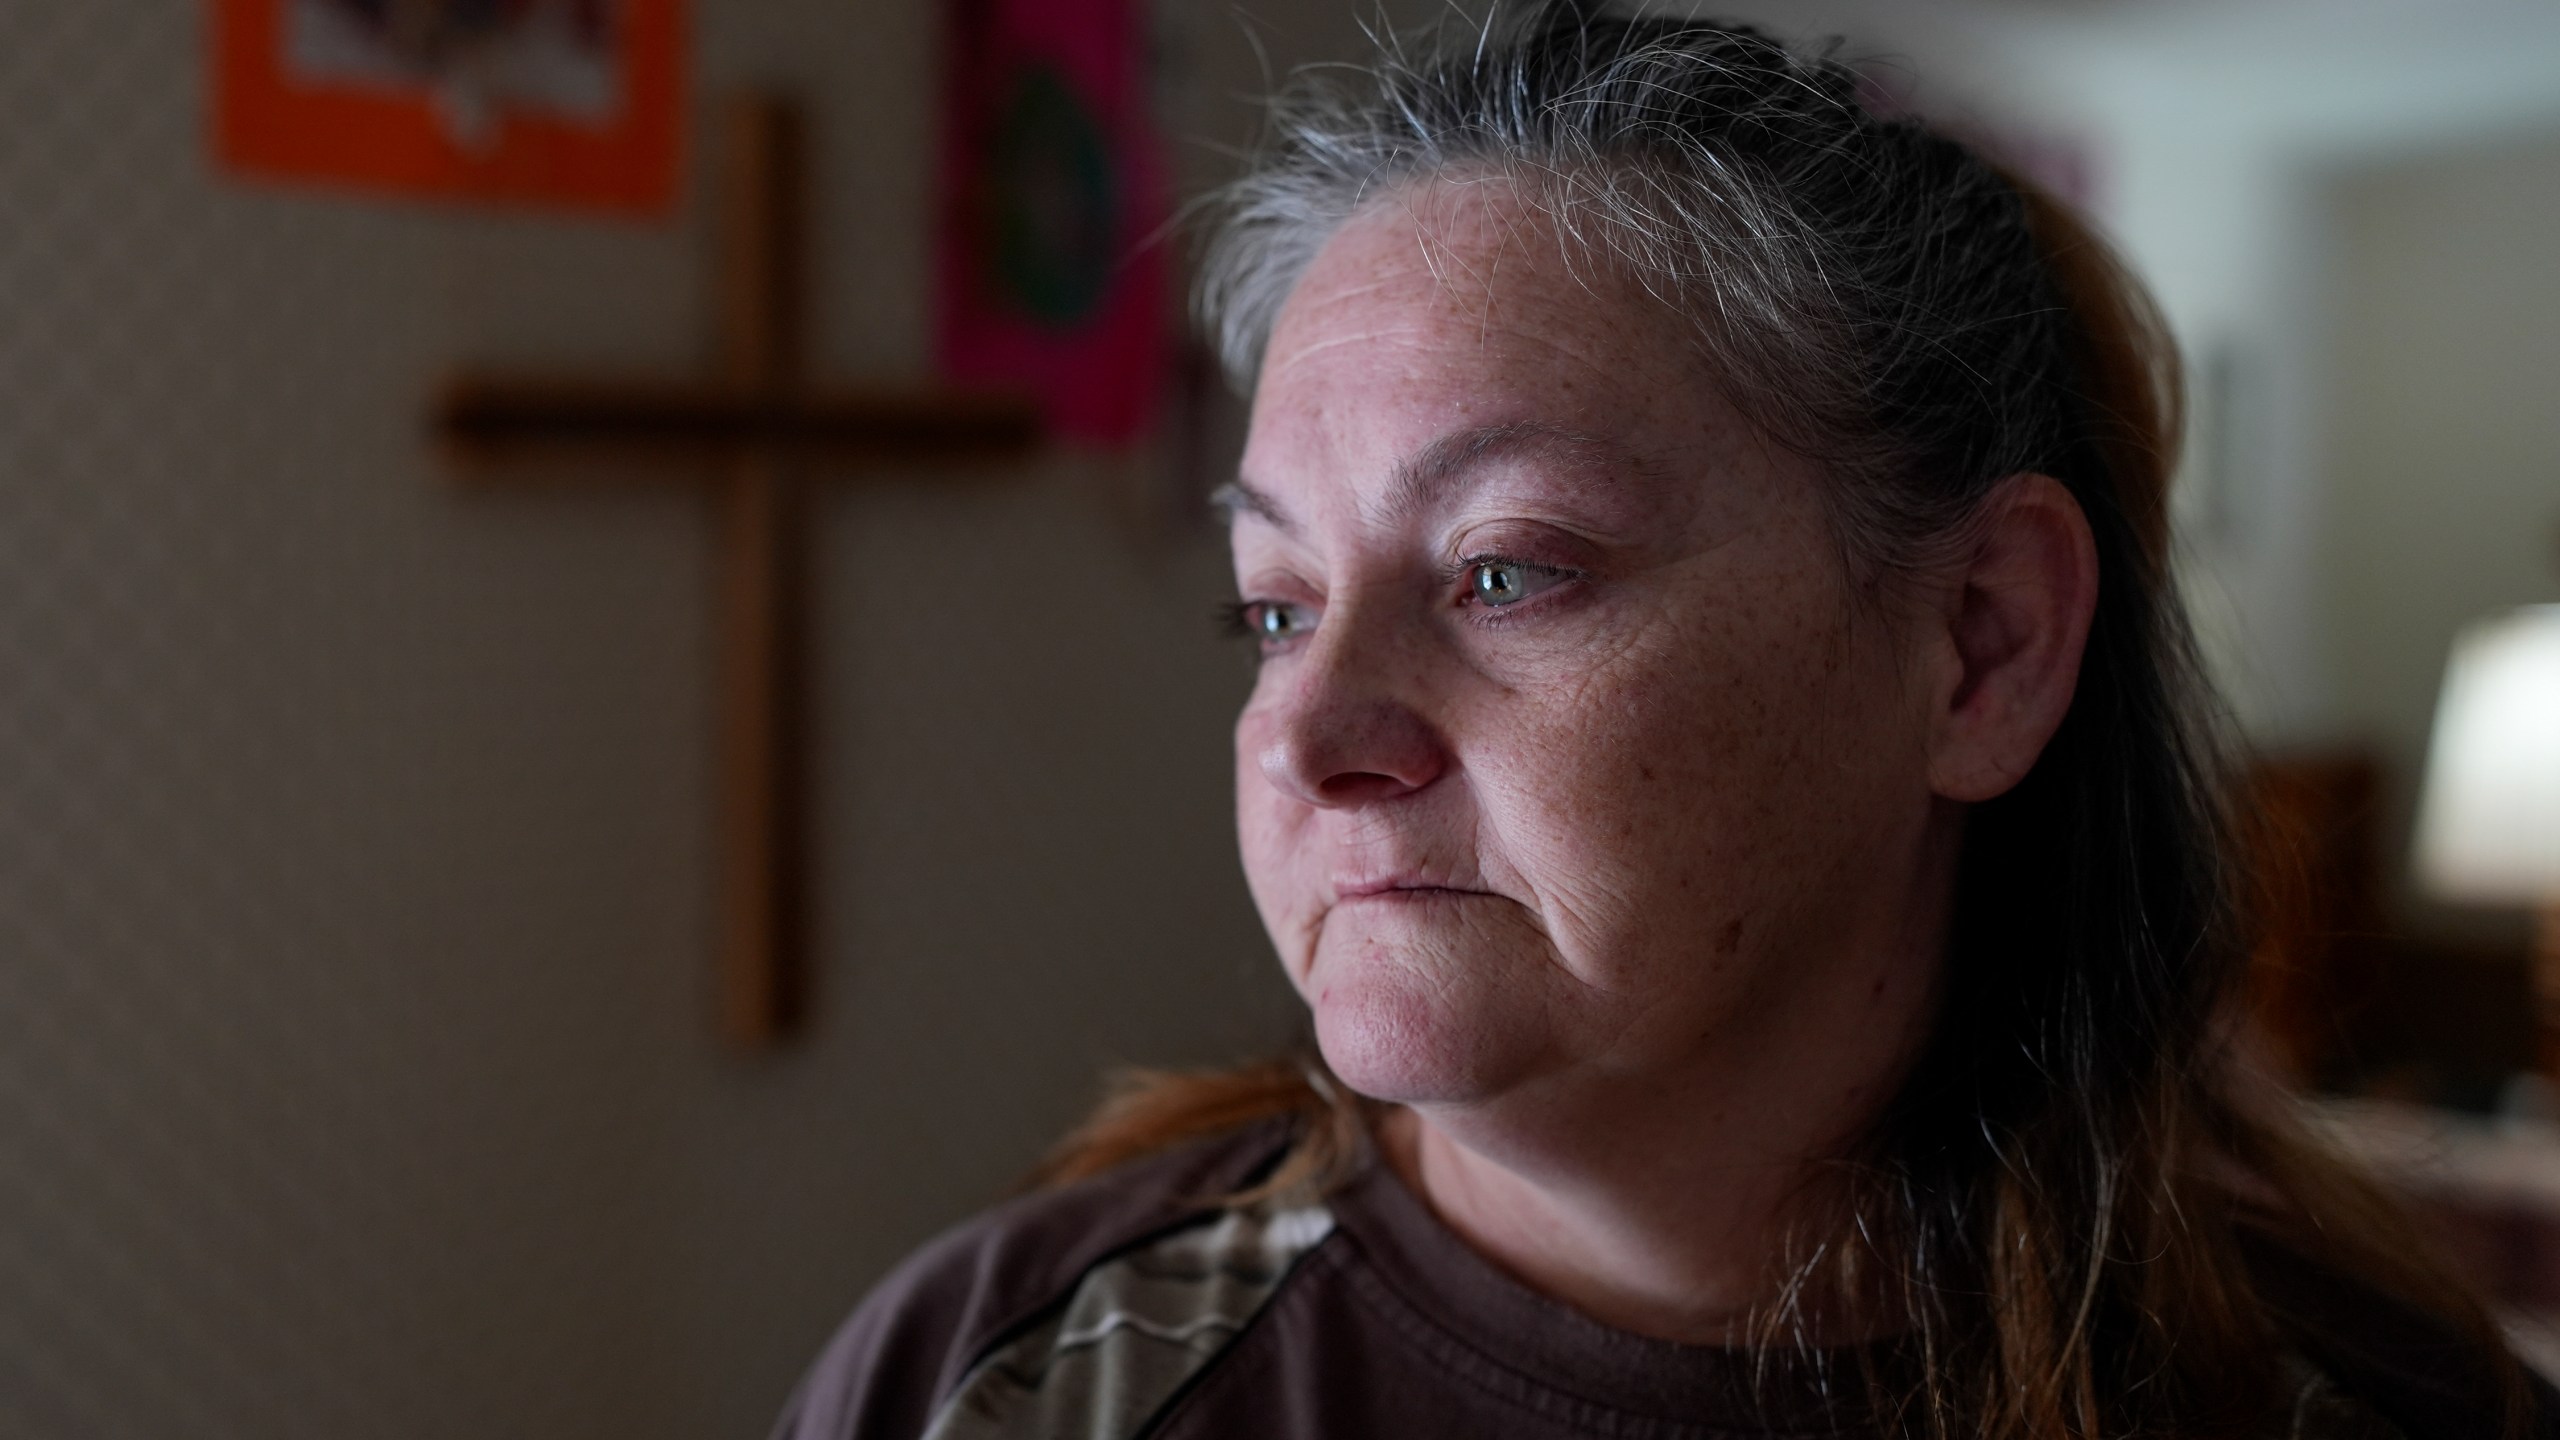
[{"x1": 2319, "y1": 131, "x2": 2560, "y2": 928}]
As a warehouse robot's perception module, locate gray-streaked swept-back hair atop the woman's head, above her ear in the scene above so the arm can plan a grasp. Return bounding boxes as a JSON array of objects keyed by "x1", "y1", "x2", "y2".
[{"x1": 1198, "y1": 5, "x2": 2140, "y2": 564}]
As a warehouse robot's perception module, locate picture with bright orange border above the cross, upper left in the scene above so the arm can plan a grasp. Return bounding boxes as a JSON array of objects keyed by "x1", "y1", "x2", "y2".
[{"x1": 212, "y1": 0, "x2": 684, "y2": 215}]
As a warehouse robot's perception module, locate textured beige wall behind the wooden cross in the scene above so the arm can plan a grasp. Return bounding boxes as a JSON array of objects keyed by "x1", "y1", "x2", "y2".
[{"x1": 0, "y1": 0, "x2": 1402, "y2": 1437}]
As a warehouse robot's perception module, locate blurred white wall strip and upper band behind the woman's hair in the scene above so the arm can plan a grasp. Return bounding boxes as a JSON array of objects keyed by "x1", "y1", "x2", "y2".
[{"x1": 2012, "y1": 0, "x2": 2560, "y2": 748}]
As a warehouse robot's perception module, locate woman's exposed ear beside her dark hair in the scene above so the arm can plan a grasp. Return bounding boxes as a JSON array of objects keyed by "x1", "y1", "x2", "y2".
[{"x1": 1928, "y1": 474, "x2": 2097, "y2": 802}]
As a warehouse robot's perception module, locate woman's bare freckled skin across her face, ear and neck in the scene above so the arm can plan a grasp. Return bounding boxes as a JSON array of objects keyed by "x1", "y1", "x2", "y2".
[{"x1": 1234, "y1": 184, "x2": 2094, "y2": 1340}]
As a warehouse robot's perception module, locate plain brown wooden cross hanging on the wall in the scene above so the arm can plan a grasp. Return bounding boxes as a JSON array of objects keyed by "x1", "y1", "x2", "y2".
[{"x1": 435, "y1": 95, "x2": 1037, "y2": 1048}]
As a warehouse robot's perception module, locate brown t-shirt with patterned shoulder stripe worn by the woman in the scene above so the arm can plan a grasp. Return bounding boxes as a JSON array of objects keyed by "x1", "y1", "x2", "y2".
[{"x1": 776, "y1": 1125, "x2": 2437, "y2": 1440}]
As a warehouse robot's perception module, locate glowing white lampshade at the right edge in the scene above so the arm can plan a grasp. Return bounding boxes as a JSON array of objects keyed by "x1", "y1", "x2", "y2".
[{"x1": 2417, "y1": 605, "x2": 2560, "y2": 907}]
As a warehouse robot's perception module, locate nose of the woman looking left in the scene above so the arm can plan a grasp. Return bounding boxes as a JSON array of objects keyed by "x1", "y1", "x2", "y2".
[{"x1": 1260, "y1": 618, "x2": 1449, "y2": 810}]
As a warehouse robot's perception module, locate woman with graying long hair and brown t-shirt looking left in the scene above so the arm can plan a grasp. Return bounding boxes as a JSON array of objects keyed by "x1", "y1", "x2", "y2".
[{"x1": 783, "y1": 8, "x2": 2547, "y2": 1440}]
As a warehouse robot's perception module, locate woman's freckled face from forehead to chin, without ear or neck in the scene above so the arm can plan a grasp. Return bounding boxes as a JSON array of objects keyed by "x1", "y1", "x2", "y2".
[{"x1": 1229, "y1": 187, "x2": 1930, "y2": 1104}]
